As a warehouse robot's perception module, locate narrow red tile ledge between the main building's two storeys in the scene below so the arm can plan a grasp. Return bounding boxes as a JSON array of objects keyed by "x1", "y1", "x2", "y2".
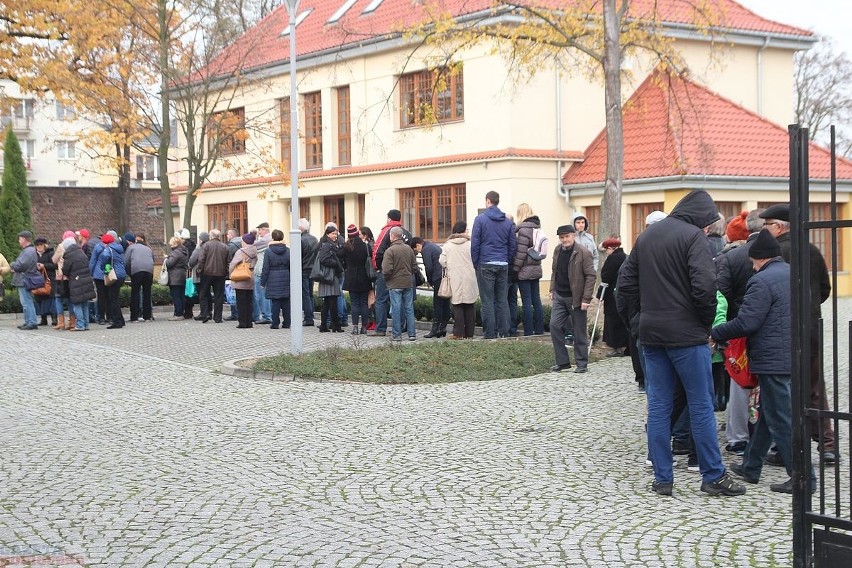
[{"x1": 172, "y1": 148, "x2": 583, "y2": 192}]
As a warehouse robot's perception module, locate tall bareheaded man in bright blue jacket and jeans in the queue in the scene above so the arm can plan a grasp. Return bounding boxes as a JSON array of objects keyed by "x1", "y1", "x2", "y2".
[{"x1": 470, "y1": 191, "x2": 517, "y2": 339}]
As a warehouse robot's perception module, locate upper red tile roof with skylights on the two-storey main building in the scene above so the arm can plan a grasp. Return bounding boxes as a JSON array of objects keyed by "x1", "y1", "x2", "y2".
[{"x1": 209, "y1": 0, "x2": 813, "y2": 75}]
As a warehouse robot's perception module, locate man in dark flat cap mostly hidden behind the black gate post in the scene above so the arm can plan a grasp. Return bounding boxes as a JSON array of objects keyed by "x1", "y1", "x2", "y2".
[{"x1": 760, "y1": 203, "x2": 838, "y2": 465}]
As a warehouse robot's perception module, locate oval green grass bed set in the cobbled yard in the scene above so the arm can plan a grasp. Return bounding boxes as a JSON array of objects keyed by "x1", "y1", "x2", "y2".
[{"x1": 252, "y1": 338, "x2": 553, "y2": 384}]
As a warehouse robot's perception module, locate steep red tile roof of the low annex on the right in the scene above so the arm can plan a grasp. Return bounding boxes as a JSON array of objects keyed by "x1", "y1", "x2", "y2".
[{"x1": 562, "y1": 69, "x2": 852, "y2": 184}]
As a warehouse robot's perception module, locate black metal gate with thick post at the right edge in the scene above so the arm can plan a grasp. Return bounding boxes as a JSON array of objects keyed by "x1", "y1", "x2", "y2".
[{"x1": 789, "y1": 125, "x2": 852, "y2": 568}]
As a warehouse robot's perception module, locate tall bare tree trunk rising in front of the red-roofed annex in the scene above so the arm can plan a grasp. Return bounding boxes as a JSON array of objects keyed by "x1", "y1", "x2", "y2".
[{"x1": 597, "y1": 0, "x2": 624, "y2": 247}]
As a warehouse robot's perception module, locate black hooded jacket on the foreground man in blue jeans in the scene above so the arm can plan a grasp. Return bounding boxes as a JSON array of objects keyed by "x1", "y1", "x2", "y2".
[{"x1": 618, "y1": 190, "x2": 719, "y2": 348}]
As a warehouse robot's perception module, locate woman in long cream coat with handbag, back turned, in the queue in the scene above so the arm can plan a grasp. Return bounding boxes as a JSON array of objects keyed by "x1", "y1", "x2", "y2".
[{"x1": 438, "y1": 221, "x2": 479, "y2": 339}]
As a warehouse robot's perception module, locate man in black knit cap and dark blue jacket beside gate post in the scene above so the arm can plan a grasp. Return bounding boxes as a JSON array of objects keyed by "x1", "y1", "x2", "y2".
[{"x1": 712, "y1": 229, "x2": 816, "y2": 493}]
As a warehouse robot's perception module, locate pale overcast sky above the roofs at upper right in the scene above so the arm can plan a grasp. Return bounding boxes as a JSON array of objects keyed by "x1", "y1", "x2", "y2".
[{"x1": 737, "y1": 0, "x2": 852, "y2": 56}]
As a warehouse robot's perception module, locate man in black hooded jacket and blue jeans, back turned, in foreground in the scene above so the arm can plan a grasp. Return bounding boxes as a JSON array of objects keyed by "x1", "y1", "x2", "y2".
[{"x1": 618, "y1": 190, "x2": 745, "y2": 496}]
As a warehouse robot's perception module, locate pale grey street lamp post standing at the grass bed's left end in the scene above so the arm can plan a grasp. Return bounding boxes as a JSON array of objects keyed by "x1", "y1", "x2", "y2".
[{"x1": 286, "y1": 0, "x2": 302, "y2": 355}]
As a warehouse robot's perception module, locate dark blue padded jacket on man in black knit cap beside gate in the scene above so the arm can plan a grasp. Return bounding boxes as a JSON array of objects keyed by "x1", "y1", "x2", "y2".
[{"x1": 712, "y1": 258, "x2": 792, "y2": 375}]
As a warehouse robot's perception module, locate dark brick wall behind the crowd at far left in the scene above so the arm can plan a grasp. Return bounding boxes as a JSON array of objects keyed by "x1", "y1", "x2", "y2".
[{"x1": 30, "y1": 187, "x2": 167, "y2": 262}]
